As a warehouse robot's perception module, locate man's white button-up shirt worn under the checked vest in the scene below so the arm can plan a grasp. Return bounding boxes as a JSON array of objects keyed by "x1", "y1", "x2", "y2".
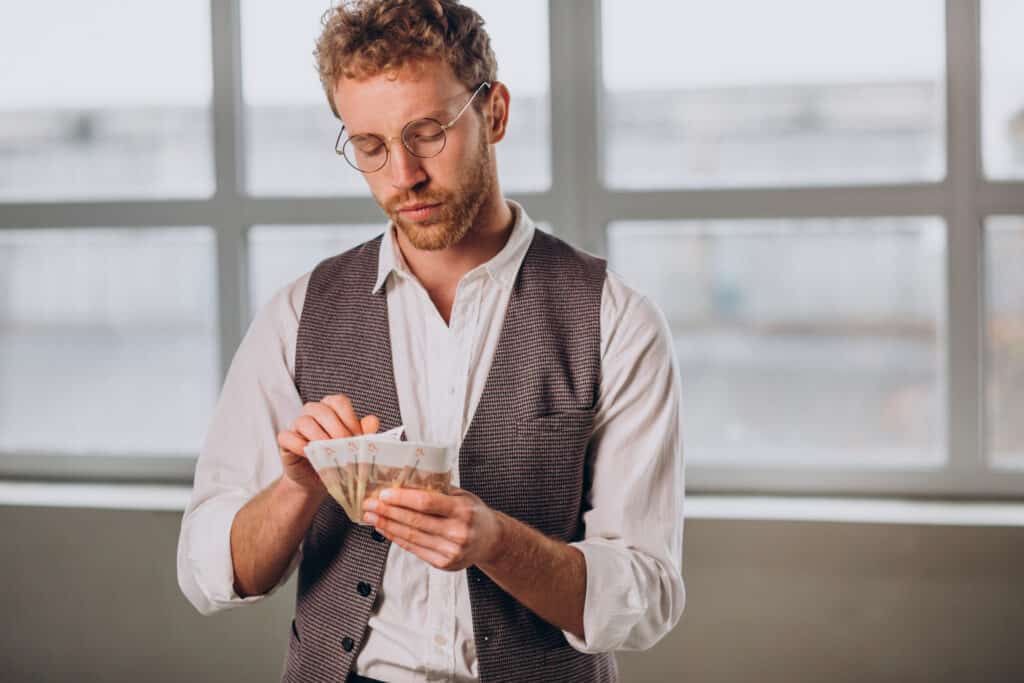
[{"x1": 177, "y1": 202, "x2": 685, "y2": 683}]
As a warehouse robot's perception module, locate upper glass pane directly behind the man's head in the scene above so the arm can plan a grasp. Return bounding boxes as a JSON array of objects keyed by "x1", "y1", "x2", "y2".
[{"x1": 242, "y1": 0, "x2": 551, "y2": 196}]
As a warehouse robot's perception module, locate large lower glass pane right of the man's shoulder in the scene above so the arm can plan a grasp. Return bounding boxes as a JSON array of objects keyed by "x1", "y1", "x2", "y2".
[{"x1": 608, "y1": 218, "x2": 945, "y2": 467}]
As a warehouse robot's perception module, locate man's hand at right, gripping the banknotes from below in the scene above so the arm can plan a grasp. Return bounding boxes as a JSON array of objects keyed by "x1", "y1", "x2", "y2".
[{"x1": 362, "y1": 488, "x2": 503, "y2": 571}]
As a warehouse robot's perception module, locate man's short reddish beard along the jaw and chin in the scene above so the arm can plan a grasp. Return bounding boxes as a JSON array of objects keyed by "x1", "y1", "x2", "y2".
[{"x1": 381, "y1": 130, "x2": 493, "y2": 251}]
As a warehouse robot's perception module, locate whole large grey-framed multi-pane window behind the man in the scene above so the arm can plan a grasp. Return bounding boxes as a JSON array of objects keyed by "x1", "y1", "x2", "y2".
[{"x1": 0, "y1": 0, "x2": 1024, "y2": 498}]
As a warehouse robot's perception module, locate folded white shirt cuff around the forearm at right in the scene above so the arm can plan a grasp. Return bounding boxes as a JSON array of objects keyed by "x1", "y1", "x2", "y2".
[{"x1": 562, "y1": 539, "x2": 647, "y2": 654}]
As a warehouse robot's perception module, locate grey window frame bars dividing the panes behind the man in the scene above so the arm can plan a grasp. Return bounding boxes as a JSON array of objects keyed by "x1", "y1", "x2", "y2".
[{"x1": 0, "y1": 0, "x2": 1024, "y2": 499}]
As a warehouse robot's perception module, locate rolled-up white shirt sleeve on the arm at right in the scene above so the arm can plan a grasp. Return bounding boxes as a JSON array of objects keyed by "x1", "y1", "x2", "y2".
[{"x1": 563, "y1": 272, "x2": 686, "y2": 653}]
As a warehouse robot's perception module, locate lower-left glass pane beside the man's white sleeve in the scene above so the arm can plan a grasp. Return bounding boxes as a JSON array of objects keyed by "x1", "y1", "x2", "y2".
[{"x1": 0, "y1": 227, "x2": 219, "y2": 456}]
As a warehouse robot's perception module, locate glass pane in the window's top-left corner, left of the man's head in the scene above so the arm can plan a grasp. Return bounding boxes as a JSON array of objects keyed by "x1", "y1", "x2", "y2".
[{"x1": 0, "y1": 0, "x2": 214, "y2": 201}]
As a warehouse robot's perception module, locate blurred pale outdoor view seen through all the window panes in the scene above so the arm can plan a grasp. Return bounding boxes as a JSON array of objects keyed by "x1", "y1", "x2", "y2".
[{"x1": 0, "y1": 0, "x2": 1024, "y2": 466}]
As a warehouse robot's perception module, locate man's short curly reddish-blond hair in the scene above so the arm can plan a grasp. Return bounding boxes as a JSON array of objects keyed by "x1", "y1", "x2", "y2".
[{"x1": 313, "y1": 0, "x2": 498, "y2": 118}]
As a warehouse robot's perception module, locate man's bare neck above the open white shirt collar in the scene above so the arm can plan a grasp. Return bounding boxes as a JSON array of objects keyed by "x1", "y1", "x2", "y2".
[{"x1": 394, "y1": 191, "x2": 514, "y2": 298}]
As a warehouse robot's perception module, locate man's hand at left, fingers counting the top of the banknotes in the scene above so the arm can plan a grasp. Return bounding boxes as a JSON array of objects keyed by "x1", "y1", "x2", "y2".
[{"x1": 278, "y1": 393, "x2": 380, "y2": 497}]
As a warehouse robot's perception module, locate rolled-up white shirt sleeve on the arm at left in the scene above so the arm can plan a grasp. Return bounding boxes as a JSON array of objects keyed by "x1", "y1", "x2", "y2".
[{"x1": 177, "y1": 275, "x2": 308, "y2": 614}]
